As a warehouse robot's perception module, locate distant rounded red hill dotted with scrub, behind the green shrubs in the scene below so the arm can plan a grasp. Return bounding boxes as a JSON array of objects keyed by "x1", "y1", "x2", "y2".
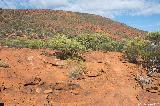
[{"x1": 0, "y1": 9, "x2": 146, "y2": 39}]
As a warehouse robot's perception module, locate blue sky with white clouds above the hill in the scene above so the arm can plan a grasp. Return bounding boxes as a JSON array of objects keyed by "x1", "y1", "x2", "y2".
[{"x1": 0, "y1": 0, "x2": 160, "y2": 31}]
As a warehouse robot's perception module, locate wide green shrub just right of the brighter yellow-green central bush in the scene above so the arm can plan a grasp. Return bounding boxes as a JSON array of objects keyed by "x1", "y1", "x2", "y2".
[{"x1": 76, "y1": 33, "x2": 123, "y2": 51}]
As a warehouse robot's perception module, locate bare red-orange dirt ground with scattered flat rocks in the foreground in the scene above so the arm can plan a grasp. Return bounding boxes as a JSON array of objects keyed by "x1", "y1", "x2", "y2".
[{"x1": 0, "y1": 48, "x2": 160, "y2": 106}]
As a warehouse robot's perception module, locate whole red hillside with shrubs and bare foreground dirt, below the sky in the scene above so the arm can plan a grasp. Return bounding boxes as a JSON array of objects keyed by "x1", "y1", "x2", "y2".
[{"x1": 0, "y1": 9, "x2": 160, "y2": 106}]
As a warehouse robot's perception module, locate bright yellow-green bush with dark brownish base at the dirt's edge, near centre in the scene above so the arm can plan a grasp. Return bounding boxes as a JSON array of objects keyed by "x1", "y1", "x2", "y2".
[{"x1": 47, "y1": 35, "x2": 86, "y2": 59}]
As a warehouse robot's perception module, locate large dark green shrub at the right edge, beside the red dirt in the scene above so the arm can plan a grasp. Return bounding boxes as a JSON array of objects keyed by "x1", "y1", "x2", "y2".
[{"x1": 124, "y1": 32, "x2": 160, "y2": 73}]
